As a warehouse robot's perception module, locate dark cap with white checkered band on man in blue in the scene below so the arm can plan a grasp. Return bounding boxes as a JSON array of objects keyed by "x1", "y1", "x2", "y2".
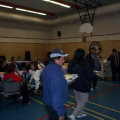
[{"x1": 50, "y1": 49, "x2": 69, "y2": 58}]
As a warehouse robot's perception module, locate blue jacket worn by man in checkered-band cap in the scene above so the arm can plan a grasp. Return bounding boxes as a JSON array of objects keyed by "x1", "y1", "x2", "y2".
[{"x1": 42, "y1": 62, "x2": 68, "y2": 117}]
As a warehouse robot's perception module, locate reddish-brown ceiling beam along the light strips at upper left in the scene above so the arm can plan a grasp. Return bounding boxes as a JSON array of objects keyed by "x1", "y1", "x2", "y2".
[{"x1": 0, "y1": 1, "x2": 55, "y2": 16}]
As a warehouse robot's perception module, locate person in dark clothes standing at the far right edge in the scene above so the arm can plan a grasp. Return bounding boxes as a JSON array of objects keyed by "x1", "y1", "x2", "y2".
[{"x1": 107, "y1": 49, "x2": 120, "y2": 81}]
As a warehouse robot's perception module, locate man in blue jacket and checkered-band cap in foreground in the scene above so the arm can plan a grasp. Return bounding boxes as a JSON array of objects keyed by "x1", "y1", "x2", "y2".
[{"x1": 42, "y1": 49, "x2": 68, "y2": 120}]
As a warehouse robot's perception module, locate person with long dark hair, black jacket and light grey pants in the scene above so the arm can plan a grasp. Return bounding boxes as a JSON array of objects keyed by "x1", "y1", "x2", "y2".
[{"x1": 68, "y1": 48, "x2": 94, "y2": 120}]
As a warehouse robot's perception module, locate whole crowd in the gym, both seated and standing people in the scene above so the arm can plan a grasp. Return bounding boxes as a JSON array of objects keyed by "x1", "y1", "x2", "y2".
[{"x1": 0, "y1": 47, "x2": 120, "y2": 120}]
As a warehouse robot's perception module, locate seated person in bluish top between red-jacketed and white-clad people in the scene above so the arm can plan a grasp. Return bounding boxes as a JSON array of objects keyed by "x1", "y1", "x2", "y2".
[{"x1": 21, "y1": 66, "x2": 31, "y2": 82}]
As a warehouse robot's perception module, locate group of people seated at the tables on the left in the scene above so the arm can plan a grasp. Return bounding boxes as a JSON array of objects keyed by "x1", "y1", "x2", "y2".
[{"x1": 0, "y1": 56, "x2": 45, "y2": 103}]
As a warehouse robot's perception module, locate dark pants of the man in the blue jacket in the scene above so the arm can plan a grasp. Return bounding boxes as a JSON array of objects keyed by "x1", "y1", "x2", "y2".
[{"x1": 45, "y1": 105, "x2": 68, "y2": 120}]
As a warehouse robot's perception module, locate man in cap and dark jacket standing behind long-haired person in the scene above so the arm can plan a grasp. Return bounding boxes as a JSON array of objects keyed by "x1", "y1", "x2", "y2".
[{"x1": 86, "y1": 47, "x2": 101, "y2": 90}]
